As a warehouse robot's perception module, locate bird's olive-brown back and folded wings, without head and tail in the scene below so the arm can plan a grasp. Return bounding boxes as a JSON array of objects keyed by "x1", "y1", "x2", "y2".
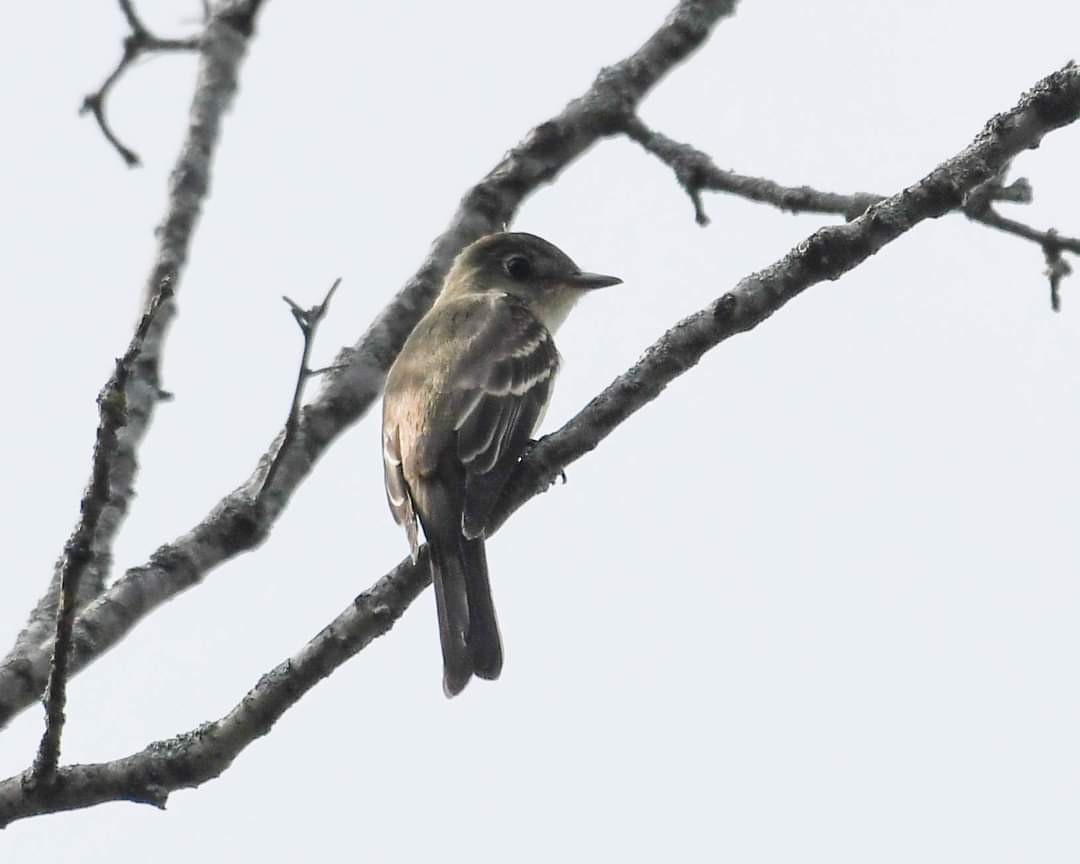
[{"x1": 382, "y1": 293, "x2": 559, "y2": 557}]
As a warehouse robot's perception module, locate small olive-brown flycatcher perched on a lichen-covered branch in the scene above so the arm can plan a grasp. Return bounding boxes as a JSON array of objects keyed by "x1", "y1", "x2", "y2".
[{"x1": 382, "y1": 231, "x2": 622, "y2": 697}]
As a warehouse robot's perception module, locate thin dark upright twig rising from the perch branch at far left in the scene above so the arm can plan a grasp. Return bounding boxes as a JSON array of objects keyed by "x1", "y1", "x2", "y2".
[{"x1": 29, "y1": 283, "x2": 173, "y2": 788}]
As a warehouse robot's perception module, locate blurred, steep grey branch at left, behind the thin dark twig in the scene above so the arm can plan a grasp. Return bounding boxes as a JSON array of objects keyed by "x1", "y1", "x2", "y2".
[{"x1": 0, "y1": 0, "x2": 267, "y2": 725}]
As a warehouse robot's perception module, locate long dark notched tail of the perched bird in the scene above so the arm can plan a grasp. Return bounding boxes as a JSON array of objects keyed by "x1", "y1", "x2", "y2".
[{"x1": 429, "y1": 531, "x2": 502, "y2": 697}]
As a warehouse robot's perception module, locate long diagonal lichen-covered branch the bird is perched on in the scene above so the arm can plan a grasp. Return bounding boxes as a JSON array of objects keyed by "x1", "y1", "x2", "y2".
[{"x1": 0, "y1": 59, "x2": 1080, "y2": 826}]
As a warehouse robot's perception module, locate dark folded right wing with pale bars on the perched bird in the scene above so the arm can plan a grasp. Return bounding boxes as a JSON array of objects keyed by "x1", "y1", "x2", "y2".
[{"x1": 447, "y1": 298, "x2": 559, "y2": 538}]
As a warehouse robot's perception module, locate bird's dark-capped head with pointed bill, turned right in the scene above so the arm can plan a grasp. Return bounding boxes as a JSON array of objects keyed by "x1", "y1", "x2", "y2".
[{"x1": 441, "y1": 231, "x2": 622, "y2": 332}]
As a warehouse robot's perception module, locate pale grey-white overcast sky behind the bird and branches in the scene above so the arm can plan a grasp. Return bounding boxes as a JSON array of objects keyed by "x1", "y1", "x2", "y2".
[{"x1": 0, "y1": 0, "x2": 1080, "y2": 864}]
